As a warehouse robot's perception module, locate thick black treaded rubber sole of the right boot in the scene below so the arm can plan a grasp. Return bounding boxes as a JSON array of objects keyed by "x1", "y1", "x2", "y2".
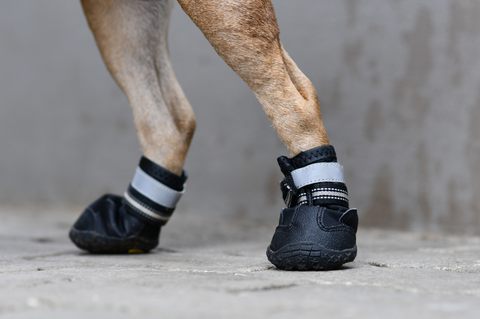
[{"x1": 267, "y1": 243, "x2": 357, "y2": 270}]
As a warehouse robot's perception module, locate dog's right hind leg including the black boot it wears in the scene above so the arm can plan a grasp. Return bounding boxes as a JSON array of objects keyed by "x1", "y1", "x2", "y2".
[{"x1": 178, "y1": 0, "x2": 358, "y2": 270}]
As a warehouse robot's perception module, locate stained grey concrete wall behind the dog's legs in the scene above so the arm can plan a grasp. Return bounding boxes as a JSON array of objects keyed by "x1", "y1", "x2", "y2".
[{"x1": 0, "y1": 0, "x2": 480, "y2": 233}]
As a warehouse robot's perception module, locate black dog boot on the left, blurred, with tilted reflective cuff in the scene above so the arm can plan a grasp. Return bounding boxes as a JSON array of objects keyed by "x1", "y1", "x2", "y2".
[{"x1": 70, "y1": 157, "x2": 187, "y2": 253}]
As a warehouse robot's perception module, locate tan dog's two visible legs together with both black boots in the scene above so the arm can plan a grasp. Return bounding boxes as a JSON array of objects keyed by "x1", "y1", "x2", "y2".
[{"x1": 70, "y1": 0, "x2": 358, "y2": 270}]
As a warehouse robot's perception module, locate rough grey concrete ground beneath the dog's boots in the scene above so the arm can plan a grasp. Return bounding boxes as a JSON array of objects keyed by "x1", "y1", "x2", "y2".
[{"x1": 0, "y1": 208, "x2": 480, "y2": 319}]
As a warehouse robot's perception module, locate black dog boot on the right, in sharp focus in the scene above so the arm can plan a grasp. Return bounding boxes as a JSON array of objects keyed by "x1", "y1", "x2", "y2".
[{"x1": 267, "y1": 145, "x2": 358, "y2": 270}]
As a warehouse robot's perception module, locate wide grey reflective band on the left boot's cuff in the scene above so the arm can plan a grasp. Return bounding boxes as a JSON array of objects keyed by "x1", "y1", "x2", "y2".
[{"x1": 132, "y1": 167, "x2": 185, "y2": 208}]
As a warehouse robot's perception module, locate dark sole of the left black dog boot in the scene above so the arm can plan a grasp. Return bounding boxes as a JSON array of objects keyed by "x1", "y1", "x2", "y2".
[{"x1": 69, "y1": 227, "x2": 158, "y2": 254}]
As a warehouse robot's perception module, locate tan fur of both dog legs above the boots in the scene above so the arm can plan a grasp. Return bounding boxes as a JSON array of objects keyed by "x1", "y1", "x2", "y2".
[{"x1": 82, "y1": 0, "x2": 329, "y2": 174}]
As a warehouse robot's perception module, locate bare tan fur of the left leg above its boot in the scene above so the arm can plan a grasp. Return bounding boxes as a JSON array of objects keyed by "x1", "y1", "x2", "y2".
[{"x1": 82, "y1": 0, "x2": 195, "y2": 175}]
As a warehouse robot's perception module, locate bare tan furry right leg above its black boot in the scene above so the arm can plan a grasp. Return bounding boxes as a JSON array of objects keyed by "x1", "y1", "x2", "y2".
[{"x1": 178, "y1": 0, "x2": 329, "y2": 156}]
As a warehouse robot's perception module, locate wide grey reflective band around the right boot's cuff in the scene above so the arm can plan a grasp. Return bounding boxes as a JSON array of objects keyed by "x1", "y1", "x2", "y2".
[{"x1": 291, "y1": 163, "x2": 345, "y2": 188}]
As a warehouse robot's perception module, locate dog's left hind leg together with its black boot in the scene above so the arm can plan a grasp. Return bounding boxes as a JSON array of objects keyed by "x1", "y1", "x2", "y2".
[{"x1": 70, "y1": 0, "x2": 195, "y2": 253}]
